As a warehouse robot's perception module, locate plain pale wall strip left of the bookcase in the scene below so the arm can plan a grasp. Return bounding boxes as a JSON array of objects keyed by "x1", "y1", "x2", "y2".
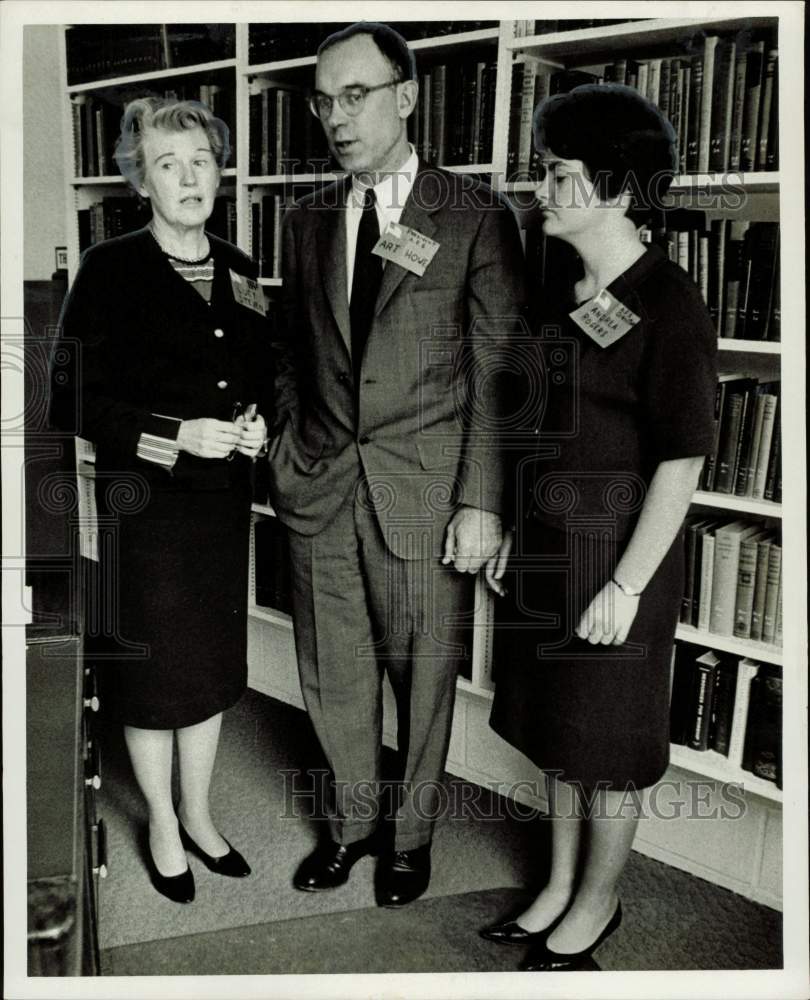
[{"x1": 23, "y1": 25, "x2": 67, "y2": 281}]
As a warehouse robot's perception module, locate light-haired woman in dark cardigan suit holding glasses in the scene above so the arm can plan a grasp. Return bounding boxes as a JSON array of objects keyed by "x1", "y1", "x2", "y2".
[{"x1": 53, "y1": 98, "x2": 271, "y2": 903}]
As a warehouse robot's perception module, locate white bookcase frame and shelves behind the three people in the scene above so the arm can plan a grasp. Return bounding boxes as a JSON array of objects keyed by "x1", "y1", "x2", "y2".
[{"x1": 61, "y1": 17, "x2": 782, "y2": 906}]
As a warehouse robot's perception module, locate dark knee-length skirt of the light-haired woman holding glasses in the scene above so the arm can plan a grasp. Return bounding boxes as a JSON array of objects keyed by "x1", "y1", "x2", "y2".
[{"x1": 86, "y1": 482, "x2": 251, "y2": 729}]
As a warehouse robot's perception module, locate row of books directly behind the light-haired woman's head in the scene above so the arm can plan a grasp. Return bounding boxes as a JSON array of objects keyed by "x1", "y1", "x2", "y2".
[{"x1": 71, "y1": 83, "x2": 236, "y2": 177}]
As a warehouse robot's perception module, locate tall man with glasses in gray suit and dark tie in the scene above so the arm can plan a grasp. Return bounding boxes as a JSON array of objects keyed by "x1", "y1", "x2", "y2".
[{"x1": 269, "y1": 23, "x2": 523, "y2": 906}]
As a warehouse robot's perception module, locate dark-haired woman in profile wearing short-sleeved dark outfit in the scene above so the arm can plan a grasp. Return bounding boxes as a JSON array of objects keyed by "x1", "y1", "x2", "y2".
[{"x1": 482, "y1": 86, "x2": 716, "y2": 970}]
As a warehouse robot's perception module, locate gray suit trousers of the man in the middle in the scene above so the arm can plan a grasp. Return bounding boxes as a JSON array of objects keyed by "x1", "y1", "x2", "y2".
[{"x1": 289, "y1": 487, "x2": 474, "y2": 850}]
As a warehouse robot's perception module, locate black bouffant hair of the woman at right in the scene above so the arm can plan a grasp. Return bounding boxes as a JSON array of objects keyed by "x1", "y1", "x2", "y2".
[{"x1": 533, "y1": 84, "x2": 678, "y2": 225}]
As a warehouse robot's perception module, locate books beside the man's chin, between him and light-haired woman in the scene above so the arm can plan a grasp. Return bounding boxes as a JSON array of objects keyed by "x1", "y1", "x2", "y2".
[{"x1": 248, "y1": 80, "x2": 330, "y2": 177}]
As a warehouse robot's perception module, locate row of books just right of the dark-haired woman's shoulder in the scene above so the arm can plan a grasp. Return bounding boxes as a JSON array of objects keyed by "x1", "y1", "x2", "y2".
[{"x1": 642, "y1": 209, "x2": 781, "y2": 341}]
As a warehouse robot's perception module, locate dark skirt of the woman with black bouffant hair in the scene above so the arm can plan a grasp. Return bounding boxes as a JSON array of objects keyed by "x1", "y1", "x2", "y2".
[{"x1": 490, "y1": 521, "x2": 684, "y2": 792}]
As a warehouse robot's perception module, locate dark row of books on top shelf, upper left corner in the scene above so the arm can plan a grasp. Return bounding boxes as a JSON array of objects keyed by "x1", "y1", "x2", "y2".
[{"x1": 66, "y1": 24, "x2": 236, "y2": 85}]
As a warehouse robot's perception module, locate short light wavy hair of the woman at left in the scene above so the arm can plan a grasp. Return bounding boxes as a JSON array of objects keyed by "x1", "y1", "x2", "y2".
[{"x1": 113, "y1": 97, "x2": 231, "y2": 191}]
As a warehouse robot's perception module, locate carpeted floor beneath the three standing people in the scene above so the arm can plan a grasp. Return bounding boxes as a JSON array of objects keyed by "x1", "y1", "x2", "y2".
[{"x1": 99, "y1": 691, "x2": 781, "y2": 975}]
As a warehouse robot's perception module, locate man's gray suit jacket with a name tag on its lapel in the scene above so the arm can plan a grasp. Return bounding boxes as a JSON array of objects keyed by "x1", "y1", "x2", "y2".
[{"x1": 269, "y1": 165, "x2": 524, "y2": 559}]
